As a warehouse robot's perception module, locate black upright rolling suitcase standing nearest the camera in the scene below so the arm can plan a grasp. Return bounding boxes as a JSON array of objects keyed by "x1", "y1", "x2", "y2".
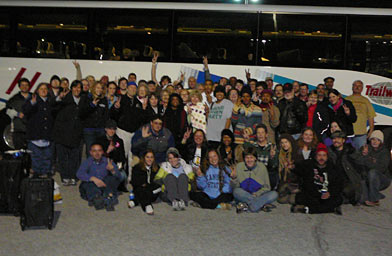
[{"x1": 20, "y1": 178, "x2": 54, "y2": 231}]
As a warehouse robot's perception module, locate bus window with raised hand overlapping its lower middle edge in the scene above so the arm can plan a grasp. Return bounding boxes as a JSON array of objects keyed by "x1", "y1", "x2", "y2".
[{"x1": 174, "y1": 11, "x2": 257, "y2": 64}]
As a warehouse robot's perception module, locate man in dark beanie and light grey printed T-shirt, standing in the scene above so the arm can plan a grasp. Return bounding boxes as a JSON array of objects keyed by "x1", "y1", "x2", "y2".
[{"x1": 207, "y1": 85, "x2": 234, "y2": 148}]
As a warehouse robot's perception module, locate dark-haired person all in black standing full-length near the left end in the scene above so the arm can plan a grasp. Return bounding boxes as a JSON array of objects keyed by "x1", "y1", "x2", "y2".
[{"x1": 53, "y1": 80, "x2": 83, "y2": 186}]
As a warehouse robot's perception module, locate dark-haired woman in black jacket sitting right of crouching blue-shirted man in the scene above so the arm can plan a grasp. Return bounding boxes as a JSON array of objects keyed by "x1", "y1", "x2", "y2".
[{"x1": 128, "y1": 149, "x2": 162, "y2": 215}]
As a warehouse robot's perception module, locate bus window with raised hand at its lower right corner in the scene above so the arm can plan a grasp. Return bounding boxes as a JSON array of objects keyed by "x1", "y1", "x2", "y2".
[{"x1": 94, "y1": 9, "x2": 171, "y2": 61}]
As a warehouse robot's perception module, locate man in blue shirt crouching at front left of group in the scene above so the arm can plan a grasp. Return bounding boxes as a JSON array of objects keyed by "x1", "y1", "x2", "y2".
[{"x1": 76, "y1": 143, "x2": 122, "y2": 211}]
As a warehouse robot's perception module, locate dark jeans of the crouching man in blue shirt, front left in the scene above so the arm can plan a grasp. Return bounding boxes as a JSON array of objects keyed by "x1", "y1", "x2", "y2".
[{"x1": 79, "y1": 175, "x2": 121, "y2": 201}]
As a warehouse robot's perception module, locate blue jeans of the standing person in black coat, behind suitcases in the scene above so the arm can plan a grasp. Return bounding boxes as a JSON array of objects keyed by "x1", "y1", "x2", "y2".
[{"x1": 27, "y1": 141, "x2": 53, "y2": 174}]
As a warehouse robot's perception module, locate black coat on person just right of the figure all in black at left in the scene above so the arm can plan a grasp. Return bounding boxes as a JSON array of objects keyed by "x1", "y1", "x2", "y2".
[{"x1": 79, "y1": 94, "x2": 109, "y2": 128}]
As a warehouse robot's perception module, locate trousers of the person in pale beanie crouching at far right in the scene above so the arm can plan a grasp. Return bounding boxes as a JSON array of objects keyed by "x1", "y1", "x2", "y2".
[{"x1": 361, "y1": 169, "x2": 391, "y2": 203}]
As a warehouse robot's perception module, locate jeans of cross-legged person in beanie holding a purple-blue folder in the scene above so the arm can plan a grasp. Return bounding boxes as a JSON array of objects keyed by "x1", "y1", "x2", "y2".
[{"x1": 233, "y1": 188, "x2": 278, "y2": 212}]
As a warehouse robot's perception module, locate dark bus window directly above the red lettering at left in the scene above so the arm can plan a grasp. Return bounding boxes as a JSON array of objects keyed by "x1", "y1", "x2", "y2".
[{"x1": 16, "y1": 8, "x2": 87, "y2": 59}]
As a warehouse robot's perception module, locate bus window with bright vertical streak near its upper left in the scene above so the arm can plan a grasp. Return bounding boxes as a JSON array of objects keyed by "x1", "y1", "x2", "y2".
[{"x1": 259, "y1": 13, "x2": 345, "y2": 68}]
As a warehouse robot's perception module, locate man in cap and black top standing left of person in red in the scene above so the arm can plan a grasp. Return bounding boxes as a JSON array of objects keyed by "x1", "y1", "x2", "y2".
[{"x1": 278, "y1": 83, "x2": 308, "y2": 139}]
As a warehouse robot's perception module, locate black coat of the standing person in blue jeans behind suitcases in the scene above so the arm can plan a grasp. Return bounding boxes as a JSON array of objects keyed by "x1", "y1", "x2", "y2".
[{"x1": 22, "y1": 96, "x2": 55, "y2": 140}]
